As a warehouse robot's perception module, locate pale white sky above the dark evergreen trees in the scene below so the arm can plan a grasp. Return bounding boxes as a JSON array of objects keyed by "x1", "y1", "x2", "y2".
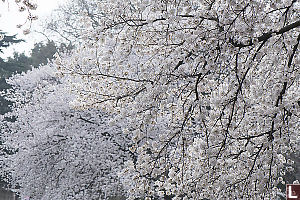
[{"x1": 0, "y1": 0, "x2": 64, "y2": 57}]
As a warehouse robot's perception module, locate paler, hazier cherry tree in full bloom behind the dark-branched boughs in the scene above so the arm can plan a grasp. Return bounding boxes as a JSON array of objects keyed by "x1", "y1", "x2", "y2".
[{"x1": 0, "y1": 65, "x2": 129, "y2": 200}]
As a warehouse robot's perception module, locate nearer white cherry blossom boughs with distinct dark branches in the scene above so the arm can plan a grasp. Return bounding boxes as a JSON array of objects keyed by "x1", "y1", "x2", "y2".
[{"x1": 56, "y1": 0, "x2": 300, "y2": 199}]
